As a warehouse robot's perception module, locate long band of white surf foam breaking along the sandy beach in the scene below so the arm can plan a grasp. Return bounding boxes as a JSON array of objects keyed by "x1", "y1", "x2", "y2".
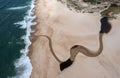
[{"x1": 8, "y1": 0, "x2": 36, "y2": 78}]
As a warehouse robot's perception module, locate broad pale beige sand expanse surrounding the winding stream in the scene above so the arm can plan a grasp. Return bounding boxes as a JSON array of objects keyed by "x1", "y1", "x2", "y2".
[{"x1": 29, "y1": 0, "x2": 120, "y2": 78}]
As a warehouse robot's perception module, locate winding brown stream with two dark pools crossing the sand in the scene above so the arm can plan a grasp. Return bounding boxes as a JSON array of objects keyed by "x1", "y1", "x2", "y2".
[{"x1": 39, "y1": 17, "x2": 111, "y2": 71}]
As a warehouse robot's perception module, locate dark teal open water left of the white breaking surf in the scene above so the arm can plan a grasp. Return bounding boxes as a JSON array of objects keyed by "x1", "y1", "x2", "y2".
[{"x1": 0, "y1": 0, "x2": 31, "y2": 78}]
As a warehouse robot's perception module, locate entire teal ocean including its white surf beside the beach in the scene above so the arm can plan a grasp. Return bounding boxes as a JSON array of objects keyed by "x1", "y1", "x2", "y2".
[{"x1": 0, "y1": 0, "x2": 36, "y2": 78}]
